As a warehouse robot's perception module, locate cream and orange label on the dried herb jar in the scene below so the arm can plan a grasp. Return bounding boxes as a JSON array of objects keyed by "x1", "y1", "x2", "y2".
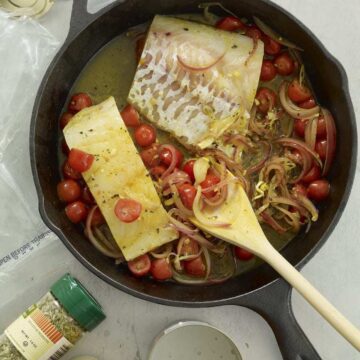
[{"x1": 5, "y1": 305, "x2": 73, "y2": 360}]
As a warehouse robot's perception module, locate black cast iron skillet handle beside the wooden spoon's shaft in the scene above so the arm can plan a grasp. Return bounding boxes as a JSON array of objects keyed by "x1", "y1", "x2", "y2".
[{"x1": 233, "y1": 279, "x2": 321, "y2": 360}]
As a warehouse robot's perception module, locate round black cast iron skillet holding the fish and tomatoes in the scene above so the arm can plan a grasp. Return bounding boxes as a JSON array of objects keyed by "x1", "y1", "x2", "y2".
[{"x1": 30, "y1": 0, "x2": 357, "y2": 360}]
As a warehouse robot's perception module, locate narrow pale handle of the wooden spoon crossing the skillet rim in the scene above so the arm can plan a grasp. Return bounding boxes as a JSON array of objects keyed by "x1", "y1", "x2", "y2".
[{"x1": 259, "y1": 244, "x2": 360, "y2": 351}]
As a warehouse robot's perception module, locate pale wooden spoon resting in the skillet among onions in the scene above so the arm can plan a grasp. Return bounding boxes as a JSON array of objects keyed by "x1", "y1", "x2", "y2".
[{"x1": 190, "y1": 179, "x2": 360, "y2": 351}]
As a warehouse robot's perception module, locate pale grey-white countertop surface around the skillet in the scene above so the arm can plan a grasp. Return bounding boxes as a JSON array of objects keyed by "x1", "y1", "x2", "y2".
[{"x1": 0, "y1": 0, "x2": 360, "y2": 360}]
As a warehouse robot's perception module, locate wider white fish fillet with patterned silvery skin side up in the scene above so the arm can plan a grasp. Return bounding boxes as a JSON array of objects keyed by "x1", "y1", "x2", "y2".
[{"x1": 128, "y1": 15, "x2": 264, "y2": 148}]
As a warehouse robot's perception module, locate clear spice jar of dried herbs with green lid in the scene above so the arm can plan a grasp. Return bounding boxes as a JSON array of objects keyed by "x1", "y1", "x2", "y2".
[{"x1": 0, "y1": 274, "x2": 105, "y2": 360}]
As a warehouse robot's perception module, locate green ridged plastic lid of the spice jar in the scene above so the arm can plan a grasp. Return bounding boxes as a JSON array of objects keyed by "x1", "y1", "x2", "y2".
[{"x1": 50, "y1": 274, "x2": 106, "y2": 331}]
